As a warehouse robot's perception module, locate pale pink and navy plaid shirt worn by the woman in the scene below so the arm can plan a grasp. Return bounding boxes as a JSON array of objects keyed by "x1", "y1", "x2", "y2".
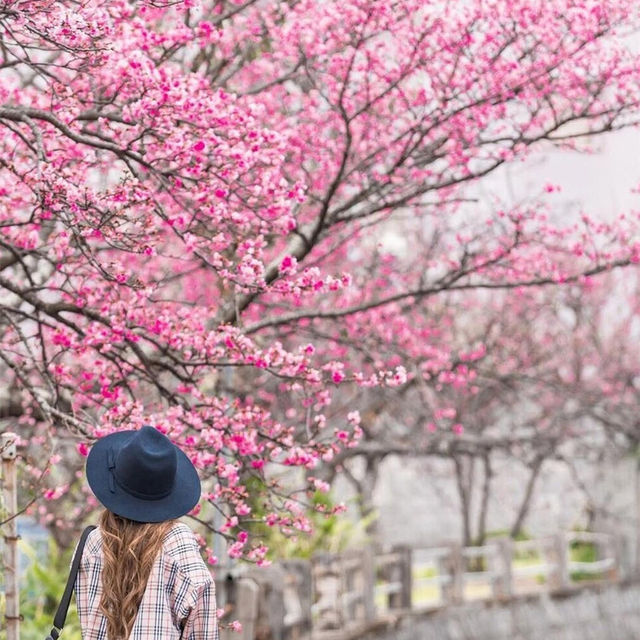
[{"x1": 76, "y1": 523, "x2": 218, "y2": 640}]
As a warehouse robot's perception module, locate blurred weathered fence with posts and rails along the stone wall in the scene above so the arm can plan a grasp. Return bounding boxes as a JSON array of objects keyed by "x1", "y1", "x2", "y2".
[{"x1": 218, "y1": 532, "x2": 624, "y2": 640}]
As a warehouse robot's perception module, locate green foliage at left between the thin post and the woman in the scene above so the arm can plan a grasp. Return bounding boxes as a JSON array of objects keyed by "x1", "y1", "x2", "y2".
[{"x1": 11, "y1": 540, "x2": 82, "y2": 640}]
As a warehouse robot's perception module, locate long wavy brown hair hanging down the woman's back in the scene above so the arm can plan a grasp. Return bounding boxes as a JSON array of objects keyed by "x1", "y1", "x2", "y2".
[{"x1": 100, "y1": 509, "x2": 175, "y2": 640}]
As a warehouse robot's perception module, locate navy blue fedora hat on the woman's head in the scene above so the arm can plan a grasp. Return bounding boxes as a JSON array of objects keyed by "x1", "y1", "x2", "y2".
[{"x1": 86, "y1": 426, "x2": 200, "y2": 522}]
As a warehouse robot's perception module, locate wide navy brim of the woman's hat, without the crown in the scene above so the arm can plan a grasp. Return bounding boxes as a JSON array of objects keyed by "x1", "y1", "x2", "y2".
[{"x1": 86, "y1": 430, "x2": 201, "y2": 522}]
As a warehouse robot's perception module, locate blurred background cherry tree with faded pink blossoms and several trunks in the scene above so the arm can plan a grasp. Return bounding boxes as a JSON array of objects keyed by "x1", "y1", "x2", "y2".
[{"x1": 324, "y1": 271, "x2": 639, "y2": 545}]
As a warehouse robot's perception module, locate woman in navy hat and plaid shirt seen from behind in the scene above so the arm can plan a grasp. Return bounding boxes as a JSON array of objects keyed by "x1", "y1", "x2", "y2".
[{"x1": 76, "y1": 427, "x2": 218, "y2": 640}]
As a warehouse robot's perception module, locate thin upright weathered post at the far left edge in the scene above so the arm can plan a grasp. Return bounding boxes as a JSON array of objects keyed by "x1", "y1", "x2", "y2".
[{"x1": 0, "y1": 433, "x2": 20, "y2": 640}]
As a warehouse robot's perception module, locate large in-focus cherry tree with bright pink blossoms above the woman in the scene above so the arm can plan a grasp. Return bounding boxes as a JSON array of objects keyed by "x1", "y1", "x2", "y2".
[{"x1": 0, "y1": 0, "x2": 640, "y2": 562}]
